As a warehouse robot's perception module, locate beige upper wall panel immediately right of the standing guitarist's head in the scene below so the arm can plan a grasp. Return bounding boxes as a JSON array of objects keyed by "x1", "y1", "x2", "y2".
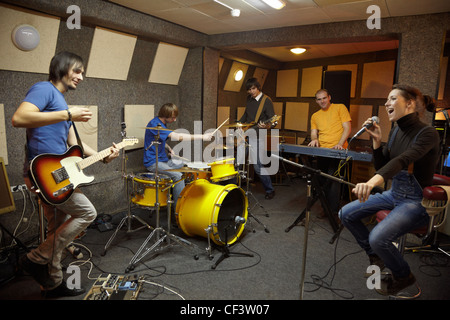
[{"x1": 86, "y1": 27, "x2": 137, "y2": 80}]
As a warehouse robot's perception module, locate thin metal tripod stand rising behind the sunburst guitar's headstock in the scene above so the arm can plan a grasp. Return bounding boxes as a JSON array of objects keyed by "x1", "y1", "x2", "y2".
[{"x1": 102, "y1": 122, "x2": 151, "y2": 256}]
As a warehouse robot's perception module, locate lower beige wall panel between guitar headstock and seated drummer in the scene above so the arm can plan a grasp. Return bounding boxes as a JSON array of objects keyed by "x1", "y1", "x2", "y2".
[{"x1": 124, "y1": 104, "x2": 155, "y2": 150}]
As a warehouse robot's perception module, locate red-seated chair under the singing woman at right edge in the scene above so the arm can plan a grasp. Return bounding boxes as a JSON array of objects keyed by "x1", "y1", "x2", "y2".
[{"x1": 376, "y1": 174, "x2": 450, "y2": 299}]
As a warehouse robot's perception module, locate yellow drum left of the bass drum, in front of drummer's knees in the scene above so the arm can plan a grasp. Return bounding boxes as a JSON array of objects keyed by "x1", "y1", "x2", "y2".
[{"x1": 131, "y1": 172, "x2": 172, "y2": 207}]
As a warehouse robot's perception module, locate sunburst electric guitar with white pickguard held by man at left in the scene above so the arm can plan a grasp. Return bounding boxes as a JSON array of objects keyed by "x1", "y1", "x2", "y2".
[{"x1": 30, "y1": 138, "x2": 139, "y2": 205}]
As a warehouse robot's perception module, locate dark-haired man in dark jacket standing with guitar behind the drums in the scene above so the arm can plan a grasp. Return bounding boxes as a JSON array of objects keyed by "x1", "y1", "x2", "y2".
[{"x1": 239, "y1": 78, "x2": 275, "y2": 200}]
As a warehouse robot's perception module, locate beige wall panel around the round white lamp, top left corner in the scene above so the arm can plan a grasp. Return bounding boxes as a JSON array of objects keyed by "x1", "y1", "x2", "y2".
[{"x1": 0, "y1": 5, "x2": 60, "y2": 74}]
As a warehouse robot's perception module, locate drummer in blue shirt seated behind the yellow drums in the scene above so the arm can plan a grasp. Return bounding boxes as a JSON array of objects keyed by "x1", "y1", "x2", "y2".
[{"x1": 144, "y1": 103, "x2": 212, "y2": 212}]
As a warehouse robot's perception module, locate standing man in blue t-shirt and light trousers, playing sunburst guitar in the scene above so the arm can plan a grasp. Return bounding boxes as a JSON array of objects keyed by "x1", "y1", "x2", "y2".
[{"x1": 12, "y1": 52, "x2": 119, "y2": 297}]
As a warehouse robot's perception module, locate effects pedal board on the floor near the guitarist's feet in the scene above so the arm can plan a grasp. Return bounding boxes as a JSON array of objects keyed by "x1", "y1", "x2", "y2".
[{"x1": 84, "y1": 274, "x2": 142, "y2": 300}]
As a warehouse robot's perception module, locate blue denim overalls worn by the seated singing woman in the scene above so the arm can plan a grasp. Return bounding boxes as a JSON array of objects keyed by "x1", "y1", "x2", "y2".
[{"x1": 339, "y1": 171, "x2": 429, "y2": 278}]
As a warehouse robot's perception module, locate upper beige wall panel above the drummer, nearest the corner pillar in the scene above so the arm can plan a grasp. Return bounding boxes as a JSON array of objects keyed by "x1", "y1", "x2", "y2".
[{"x1": 148, "y1": 42, "x2": 189, "y2": 85}]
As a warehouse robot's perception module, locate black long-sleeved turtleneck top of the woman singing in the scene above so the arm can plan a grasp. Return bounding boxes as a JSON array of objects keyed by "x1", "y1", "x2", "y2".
[{"x1": 373, "y1": 113, "x2": 440, "y2": 188}]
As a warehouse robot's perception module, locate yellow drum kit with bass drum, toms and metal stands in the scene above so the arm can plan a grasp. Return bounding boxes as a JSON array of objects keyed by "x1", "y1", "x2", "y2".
[{"x1": 103, "y1": 122, "x2": 267, "y2": 272}]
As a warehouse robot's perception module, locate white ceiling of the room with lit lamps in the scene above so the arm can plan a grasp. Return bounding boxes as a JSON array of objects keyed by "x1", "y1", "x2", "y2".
[{"x1": 109, "y1": 0, "x2": 450, "y2": 62}]
